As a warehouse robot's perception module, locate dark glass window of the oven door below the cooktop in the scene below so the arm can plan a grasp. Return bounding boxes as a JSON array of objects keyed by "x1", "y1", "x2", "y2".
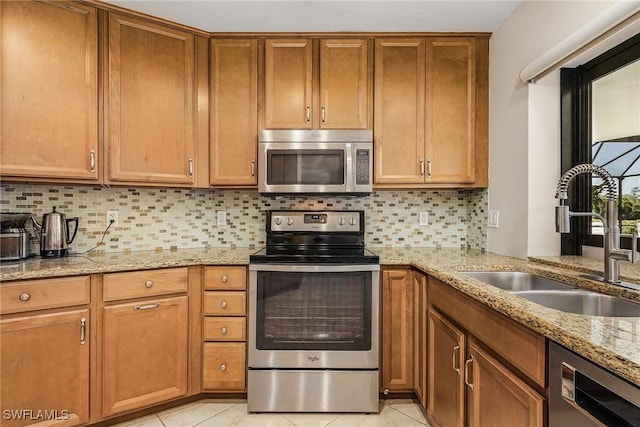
[{"x1": 256, "y1": 271, "x2": 372, "y2": 351}]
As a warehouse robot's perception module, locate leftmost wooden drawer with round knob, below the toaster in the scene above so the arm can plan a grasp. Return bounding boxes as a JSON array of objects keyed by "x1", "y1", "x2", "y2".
[{"x1": 0, "y1": 276, "x2": 91, "y2": 314}]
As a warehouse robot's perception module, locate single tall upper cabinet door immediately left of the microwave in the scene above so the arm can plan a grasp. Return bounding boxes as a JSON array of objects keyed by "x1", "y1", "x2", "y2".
[{"x1": 209, "y1": 39, "x2": 258, "y2": 185}]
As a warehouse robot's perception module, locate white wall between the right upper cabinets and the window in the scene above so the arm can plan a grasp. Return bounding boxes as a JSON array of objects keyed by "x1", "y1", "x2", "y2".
[{"x1": 487, "y1": 0, "x2": 628, "y2": 258}]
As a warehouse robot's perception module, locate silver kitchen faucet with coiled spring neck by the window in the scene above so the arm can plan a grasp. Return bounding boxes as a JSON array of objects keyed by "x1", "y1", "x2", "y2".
[{"x1": 556, "y1": 163, "x2": 637, "y2": 284}]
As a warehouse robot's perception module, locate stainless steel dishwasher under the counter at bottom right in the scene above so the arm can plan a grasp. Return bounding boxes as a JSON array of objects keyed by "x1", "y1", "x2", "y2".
[{"x1": 548, "y1": 342, "x2": 640, "y2": 427}]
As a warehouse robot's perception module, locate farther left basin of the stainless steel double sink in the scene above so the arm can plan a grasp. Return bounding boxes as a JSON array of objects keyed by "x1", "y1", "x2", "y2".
[{"x1": 462, "y1": 271, "x2": 577, "y2": 292}]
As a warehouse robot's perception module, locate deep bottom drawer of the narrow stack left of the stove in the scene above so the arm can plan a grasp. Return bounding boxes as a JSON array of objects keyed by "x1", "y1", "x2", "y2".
[{"x1": 202, "y1": 343, "x2": 247, "y2": 391}]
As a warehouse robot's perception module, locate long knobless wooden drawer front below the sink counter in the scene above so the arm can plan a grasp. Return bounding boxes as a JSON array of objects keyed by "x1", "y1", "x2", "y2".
[{"x1": 429, "y1": 277, "x2": 546, "y2": 387}]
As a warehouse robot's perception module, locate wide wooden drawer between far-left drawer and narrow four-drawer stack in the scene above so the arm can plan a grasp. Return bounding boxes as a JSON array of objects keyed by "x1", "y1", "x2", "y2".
[{"x1": 102, "y1": 267, "x2": 187, "y2": 301}]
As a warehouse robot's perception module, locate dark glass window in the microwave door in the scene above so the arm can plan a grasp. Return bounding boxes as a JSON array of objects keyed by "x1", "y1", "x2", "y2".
[{"x1": 267, "y1": 150, "x2": 345, "y2": 185}]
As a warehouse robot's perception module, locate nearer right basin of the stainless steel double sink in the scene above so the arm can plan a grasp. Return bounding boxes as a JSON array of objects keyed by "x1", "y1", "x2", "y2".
[{"x1": 513, "y1": 290, "x2": 640, "y2": 317}]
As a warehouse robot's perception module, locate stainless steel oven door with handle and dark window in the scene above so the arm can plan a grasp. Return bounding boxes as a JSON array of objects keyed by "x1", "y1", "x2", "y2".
[{"x1": 249, "y1": 264, "x2": 380, "y2": 369}]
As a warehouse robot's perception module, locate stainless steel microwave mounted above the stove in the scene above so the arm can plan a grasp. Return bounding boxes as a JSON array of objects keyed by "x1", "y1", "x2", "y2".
[{"x1": 258, "y1": 130, "x2": 373, "y2": 194}]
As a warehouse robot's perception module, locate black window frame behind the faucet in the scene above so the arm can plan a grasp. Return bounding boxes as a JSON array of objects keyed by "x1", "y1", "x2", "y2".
[{"x1": 560, "y1": 34, "x2": 640, "y2": 255}]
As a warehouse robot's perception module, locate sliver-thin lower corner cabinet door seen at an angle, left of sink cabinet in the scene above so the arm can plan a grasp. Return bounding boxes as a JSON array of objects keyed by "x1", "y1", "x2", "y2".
[{"x1": 413, "y1": 271, "x2": 429, "y2": 408}]
